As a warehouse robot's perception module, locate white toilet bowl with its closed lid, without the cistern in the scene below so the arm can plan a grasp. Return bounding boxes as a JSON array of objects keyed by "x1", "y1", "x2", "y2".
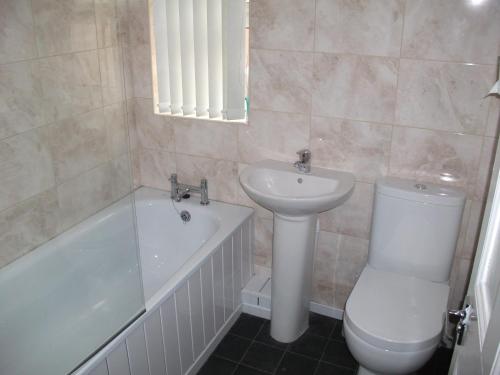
[{"x1": 344, "y1": 265, "x2": 449, "y2": 374}]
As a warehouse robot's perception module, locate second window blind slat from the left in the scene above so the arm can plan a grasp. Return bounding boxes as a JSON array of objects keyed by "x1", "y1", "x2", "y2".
[{"x1": 165, "y1": 0, "x2": 184, "y2": 114}]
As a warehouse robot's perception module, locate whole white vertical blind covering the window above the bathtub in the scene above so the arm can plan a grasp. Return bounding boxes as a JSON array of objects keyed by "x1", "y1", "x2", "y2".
[{"x1": 151, "y1": 0, "x2": 246, "y2": 120}]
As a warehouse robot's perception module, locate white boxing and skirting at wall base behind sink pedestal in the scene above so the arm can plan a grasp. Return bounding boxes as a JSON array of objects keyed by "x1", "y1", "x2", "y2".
[{"x1": 241, "y1": 275, "x2": 344, "y2": 319}]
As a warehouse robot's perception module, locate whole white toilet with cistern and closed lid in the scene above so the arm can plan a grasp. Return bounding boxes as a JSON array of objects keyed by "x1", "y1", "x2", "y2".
[{"x1": 343, "y1": 177, "x2": 465, "y2": 375}]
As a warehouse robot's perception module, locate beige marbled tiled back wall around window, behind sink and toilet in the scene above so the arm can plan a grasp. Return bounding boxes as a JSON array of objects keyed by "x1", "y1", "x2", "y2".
[{"x1": 127, "y1": 0, "x2": 500, "y2": 308}]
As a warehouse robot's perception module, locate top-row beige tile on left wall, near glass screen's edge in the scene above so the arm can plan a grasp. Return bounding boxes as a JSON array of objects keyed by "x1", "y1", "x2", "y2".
[{"x1": 94, "y1": 0, "x2": 118, "y2": 48}]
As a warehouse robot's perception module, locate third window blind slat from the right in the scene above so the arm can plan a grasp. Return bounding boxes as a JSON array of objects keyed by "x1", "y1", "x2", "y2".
[{"x1": 193, "y1": 0, "x2": 209, "y2": 116}]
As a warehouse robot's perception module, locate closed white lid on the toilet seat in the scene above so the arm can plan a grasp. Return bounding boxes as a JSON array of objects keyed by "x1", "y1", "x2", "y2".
[{"x1": 345, "y1": 266, "x2": 449, "y2": 351}]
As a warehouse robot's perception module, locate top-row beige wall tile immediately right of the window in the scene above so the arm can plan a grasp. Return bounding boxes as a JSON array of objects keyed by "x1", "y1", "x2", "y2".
[{"x1": 250, "y1": 0, "x2": 315, "y2": 51}]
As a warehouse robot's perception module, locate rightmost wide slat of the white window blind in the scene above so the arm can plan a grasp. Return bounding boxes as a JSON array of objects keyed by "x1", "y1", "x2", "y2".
[{"x1": 222, "y1": 0, "x2": 245, "y2": 120}]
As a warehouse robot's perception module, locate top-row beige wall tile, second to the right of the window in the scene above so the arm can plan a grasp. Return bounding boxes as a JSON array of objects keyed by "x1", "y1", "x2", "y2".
[{"x1": 315, "y1": 0, "x2": 404, "y2": 57}]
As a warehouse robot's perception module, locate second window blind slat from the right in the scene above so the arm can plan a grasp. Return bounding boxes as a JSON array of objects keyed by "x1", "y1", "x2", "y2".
[{"x1": 207, "y1": 0, "x2": 223, "y2": 118}]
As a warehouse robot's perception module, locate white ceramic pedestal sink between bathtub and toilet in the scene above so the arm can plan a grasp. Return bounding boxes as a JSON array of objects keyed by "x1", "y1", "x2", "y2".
[{"x1": 240, "y1": 160, "x2": 354, "y2": 342}]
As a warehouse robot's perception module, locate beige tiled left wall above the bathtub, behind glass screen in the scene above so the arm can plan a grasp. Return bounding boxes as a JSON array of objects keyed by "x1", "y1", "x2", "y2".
[{"x1": 0, "y1": 0, "x2": 135, "y2": 267}]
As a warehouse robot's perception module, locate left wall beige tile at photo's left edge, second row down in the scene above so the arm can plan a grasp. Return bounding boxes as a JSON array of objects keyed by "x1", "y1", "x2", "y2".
[{"x1": 0, "y1": 62, "x2": 45, "y2": 139}]
